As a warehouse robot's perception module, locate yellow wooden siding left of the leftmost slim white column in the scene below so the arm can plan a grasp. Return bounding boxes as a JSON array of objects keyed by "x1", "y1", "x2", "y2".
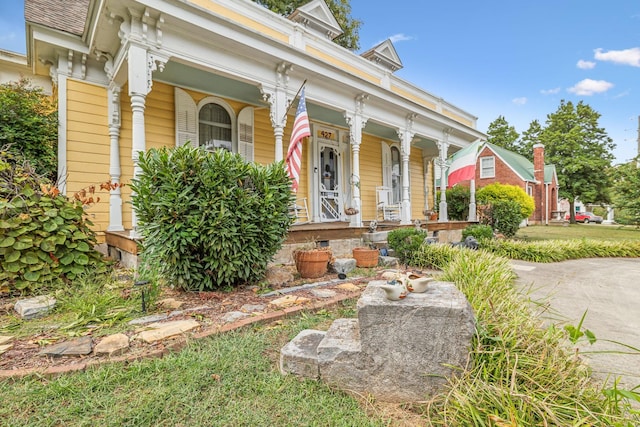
[{"x1": 66, "y1": 79, "x2": 109, "y2": 242}]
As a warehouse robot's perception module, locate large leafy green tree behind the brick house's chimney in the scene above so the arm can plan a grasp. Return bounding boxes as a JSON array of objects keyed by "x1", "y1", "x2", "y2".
[{"x1": 540, "y1": 100, "x2": 615, "y2": 223}]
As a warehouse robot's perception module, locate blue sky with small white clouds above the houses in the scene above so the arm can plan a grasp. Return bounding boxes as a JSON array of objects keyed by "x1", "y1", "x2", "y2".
[{"x1": 0, "y1": 0, "x2": 640, "y2": 162}]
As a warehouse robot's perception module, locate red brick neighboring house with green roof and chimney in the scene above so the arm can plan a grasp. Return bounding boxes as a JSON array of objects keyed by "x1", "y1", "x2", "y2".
[{"x1": 476, "y1": 142, "x2": 558, "y2": 224}]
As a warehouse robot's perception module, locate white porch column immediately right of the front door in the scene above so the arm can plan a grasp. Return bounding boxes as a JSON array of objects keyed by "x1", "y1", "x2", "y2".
[{"x1": 344, "y1": 93, "x2": 369, "y2": 227}]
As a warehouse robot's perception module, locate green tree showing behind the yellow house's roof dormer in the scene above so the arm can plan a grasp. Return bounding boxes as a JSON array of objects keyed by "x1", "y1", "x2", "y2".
[{"x1": 253, "y1": 0, "x2": 362, "y2": 50}]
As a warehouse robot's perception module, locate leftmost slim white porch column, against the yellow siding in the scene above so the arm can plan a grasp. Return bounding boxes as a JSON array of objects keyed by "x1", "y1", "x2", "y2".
[{"x1": 107, "y1": 84, "x2": 124, "y2": 231}]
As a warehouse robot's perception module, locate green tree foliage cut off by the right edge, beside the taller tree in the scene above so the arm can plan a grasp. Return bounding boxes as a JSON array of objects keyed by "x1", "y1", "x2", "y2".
[{"x1": 611, "y1": 157, "x2": 640, "y2": 225}]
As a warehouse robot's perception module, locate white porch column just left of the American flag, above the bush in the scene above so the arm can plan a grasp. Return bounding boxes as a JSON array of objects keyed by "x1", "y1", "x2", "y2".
[{"x1": 260, "y1": 62, "x2": 291, "y2": 162}]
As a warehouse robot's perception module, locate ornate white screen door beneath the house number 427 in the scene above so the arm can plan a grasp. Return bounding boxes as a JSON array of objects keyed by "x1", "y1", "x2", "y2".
[{"x1": 318, "y1": 143, "x2": 342, "y2": 222}]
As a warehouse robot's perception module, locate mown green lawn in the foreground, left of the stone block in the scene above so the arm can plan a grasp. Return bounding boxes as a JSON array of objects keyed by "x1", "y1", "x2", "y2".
[{"x1": 0, "y1": 301, "x2": 396, "y2": 426}]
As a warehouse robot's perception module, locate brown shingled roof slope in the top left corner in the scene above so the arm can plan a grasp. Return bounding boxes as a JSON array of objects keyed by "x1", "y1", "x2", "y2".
[{"x1": 24, "y1": 0, "x2": 90, "y2": 36}]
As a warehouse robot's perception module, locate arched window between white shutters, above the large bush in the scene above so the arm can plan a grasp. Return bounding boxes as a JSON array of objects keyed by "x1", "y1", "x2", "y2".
[{"x1": 198, "y1": 102, "x2": 233, "y2": 151}]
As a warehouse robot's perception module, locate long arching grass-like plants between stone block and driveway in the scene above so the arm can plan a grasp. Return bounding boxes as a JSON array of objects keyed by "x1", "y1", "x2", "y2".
[{"x1": 420, "y1": 249, "x2": 640, "y2": 426}]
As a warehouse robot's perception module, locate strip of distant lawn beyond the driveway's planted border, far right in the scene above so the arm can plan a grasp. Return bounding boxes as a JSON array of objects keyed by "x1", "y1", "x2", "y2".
[{"x1": 516, "y1": 224, "x2": 640, "y2": 241}]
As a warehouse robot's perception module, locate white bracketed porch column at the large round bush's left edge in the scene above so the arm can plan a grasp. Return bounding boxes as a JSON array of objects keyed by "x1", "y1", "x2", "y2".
[{"x1": 127, "y1": 44, "x2": 167, "y2": 237}]
